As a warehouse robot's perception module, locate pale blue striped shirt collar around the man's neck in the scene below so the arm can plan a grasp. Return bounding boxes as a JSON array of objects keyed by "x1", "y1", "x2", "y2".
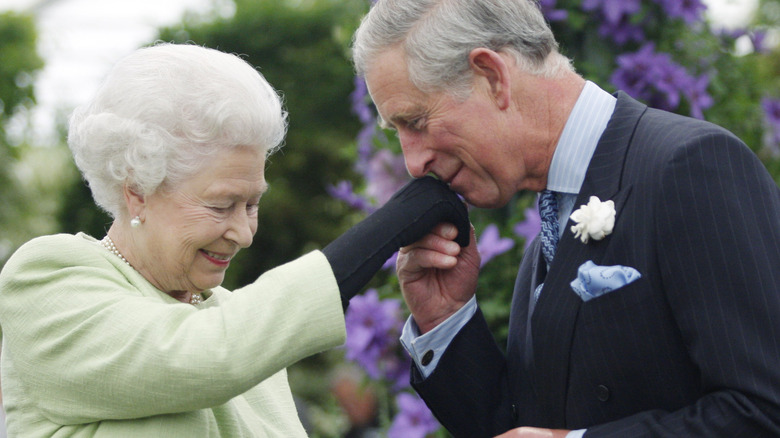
[{"x1": 547, "y1": 81, "x2": 617, "y2": 194}]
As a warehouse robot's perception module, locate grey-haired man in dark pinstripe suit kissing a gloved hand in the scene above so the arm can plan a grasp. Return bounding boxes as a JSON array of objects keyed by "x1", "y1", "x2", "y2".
[{"x1": 353, "y1": 0, "x2": 780, "y2": 438}]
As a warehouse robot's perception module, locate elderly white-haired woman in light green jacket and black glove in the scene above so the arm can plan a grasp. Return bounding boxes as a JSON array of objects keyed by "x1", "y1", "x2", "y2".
[{"x1": 0, "y1": 45, "x2": 470, "y2": 438}]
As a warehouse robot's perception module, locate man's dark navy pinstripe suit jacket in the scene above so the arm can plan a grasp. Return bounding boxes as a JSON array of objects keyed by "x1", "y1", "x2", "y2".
[{"x1": 412, "y1": 93, "x2": 780, "y2": 438}]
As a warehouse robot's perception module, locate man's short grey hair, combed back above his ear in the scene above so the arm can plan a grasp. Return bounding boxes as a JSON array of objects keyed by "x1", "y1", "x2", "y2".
[{"x1": 352, "y1": 0, "x2": 573, "y2": 97}]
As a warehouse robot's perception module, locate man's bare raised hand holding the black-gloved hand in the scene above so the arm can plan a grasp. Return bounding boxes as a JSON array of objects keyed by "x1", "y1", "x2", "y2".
[{"x1": 396, "y1": 223, "x2": 480, "y2": 333}]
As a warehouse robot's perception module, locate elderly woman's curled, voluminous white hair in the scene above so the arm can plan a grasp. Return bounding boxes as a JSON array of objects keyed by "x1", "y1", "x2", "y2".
[{"x1": 68, "y1": 44, "x2": 287, "y2": 218}]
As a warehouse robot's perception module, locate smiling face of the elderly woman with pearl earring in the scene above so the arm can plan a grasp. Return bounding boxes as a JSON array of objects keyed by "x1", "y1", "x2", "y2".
[{"x1": 132, "y1": 147, "x2": 268, "y2": 296}]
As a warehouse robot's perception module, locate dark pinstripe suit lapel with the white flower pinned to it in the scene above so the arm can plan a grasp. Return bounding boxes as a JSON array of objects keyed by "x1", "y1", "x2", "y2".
[{"x1": 530, "y1": 93, "x2": 647, "y2": 427}]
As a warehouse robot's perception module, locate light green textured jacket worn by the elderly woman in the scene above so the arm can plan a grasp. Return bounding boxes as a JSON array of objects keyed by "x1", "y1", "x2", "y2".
[{"x1": 0, "y1": 234, "x2": 345, "y2": 438}]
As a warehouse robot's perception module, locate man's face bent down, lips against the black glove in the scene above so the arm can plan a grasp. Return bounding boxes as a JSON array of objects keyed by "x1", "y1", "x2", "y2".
[{"x1": 366, "y1": 48, "x2": 544, "y2": 208}]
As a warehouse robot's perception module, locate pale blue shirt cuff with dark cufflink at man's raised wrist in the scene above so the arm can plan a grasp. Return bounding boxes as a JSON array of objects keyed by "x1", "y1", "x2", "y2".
[{"x1": 401, "y1": 296, "x2": 477, "y2": 379}]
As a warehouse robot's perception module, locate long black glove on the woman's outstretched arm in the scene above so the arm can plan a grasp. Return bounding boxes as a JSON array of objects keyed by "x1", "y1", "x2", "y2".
[{"x1": 322, "y1": 176, "x2": 471, "y2": 310}]
